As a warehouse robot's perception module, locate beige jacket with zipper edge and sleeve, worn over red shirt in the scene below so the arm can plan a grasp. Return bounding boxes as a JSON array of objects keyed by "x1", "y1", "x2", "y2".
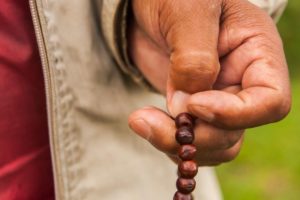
[{"x1": 30, "y1": 0, "x2": 285, "y2": 200}]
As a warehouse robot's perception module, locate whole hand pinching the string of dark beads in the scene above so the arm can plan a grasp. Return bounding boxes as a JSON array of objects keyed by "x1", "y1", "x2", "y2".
[{"x1": 129, "y1": 0, "x2": 290, "y2": 165}]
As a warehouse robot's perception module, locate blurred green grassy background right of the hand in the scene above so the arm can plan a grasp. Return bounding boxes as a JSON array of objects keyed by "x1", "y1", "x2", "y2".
[{"x1": 217, "y1": 0, "x2": 300, "y2": 200}]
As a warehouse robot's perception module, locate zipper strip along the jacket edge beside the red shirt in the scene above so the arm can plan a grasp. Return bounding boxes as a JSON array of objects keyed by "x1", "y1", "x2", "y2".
[{"x1": 29, "y1": 0, "x2": 63, "y2": 200}]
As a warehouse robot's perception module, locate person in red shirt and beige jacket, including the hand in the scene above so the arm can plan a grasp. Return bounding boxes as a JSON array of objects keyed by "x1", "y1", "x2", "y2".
[{"x1": 0, "y1": 0, "x2": 290, "y2": 200}]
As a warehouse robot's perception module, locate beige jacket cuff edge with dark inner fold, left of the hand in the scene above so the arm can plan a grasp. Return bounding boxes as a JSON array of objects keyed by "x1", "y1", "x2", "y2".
[{"x1": 98, "y1": 0, "x2": 156, "y2": 91}]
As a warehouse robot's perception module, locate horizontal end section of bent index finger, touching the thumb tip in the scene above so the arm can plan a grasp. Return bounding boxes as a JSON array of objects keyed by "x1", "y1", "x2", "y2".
[{"x1": 188, "y1": 86, "x2": 290, "y2": 129}]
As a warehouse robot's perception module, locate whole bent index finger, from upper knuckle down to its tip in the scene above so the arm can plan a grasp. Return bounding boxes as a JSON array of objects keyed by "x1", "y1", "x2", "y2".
[{"x1": 188, "y1": 1, "x2": 291, "y2": 129}]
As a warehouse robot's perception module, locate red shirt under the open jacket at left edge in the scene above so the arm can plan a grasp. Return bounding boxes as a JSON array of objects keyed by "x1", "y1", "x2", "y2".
[{"x1": 0, "y1": 0, "x2": 54, "y2": 200}]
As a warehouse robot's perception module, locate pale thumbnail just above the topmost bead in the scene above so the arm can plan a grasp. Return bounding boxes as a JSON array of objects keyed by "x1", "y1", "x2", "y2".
[{"x1": 167, "y1": 90, "x2": 190, "y2": 117}]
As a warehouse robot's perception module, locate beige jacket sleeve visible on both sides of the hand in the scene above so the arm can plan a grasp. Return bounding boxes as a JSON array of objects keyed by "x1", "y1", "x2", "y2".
[{"x1": 98, "y1": 0, "x2": 287, "y2": 89}]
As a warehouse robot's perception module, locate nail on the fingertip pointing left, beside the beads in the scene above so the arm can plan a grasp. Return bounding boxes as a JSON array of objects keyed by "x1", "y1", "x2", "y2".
[{"x1": 129, "y1": 119, "x2": 152, "y2": 141}]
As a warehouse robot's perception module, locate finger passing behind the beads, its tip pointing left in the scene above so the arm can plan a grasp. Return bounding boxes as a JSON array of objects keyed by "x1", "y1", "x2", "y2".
[{"x1": 128, "y1": 107, "x2": 243, "y2": 155}]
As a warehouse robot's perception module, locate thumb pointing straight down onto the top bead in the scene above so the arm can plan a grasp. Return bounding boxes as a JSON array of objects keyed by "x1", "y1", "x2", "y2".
[{"x1": 161, "y1": 0, "x2": 221, "y2": 116}]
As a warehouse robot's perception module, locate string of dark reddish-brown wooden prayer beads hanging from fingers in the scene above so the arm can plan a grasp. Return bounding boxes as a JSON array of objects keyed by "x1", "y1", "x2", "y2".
[{"x1": 173, "y1": 113, "x2": 198, "y2": 200}]
